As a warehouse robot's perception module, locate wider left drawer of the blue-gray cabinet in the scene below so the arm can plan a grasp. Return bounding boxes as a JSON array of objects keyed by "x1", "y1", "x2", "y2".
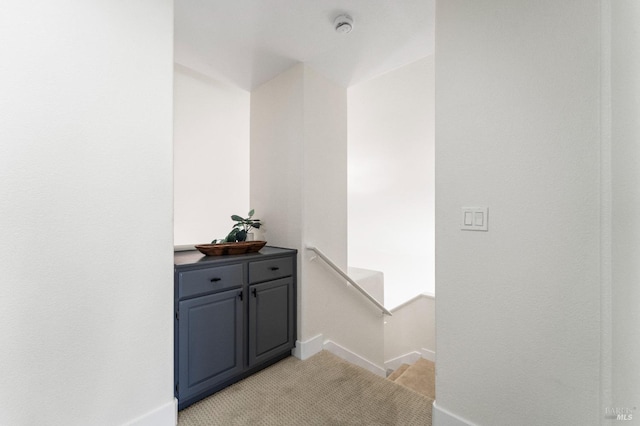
[{"x1": 178, "y1": 265, "x2": 242, "y2": 299}]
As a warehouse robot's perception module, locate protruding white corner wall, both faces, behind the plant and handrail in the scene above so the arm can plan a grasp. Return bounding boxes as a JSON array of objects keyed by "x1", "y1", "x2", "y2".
[{"x1": 251, "y1": 64, "x2": 383, "y2": 365}]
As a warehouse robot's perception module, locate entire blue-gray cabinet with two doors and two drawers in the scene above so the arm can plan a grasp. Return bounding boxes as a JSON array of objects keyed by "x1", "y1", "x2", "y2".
[{"x1": 174, "y1": 247, "x2": 297, "y2": 409}]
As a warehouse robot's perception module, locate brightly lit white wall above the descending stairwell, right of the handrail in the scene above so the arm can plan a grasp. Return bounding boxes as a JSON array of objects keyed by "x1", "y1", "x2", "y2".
[{"x1": 348, "y1": 56, "x2": 435, "y2": 307}]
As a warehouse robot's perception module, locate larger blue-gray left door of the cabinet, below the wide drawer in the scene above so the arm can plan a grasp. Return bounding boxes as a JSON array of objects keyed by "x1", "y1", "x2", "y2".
[{"x1": 178, "y1": 289, "x2": 244, "y2": 400}]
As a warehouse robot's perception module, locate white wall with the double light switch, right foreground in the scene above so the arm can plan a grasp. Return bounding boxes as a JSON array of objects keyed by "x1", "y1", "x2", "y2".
[{"x1": 435, "y1": 0, "x2": 603, "y2": 425}]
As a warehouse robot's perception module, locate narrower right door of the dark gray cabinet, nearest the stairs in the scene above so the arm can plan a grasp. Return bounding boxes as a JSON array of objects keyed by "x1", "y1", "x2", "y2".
[{"x1": 249, "y1": 278, "x2": 295, "y2": 365}]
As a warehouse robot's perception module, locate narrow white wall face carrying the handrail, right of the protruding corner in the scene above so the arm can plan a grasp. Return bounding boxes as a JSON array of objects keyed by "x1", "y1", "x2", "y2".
[{"x1": 301, "y1": 67, "x2": 384, "y2": 366}]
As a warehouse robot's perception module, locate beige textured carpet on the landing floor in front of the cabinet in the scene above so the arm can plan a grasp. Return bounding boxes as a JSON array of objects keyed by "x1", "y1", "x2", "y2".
[{"x1": 178, "y1": 351, "x2": 433, "y2": 426}]
